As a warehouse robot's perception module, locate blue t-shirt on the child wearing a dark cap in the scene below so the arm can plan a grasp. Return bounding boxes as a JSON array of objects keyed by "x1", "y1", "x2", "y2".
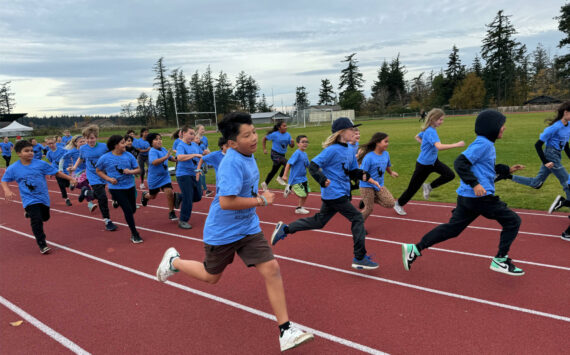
[{"x1": 313, "y1": 143, "x2": 358, "y2": 200}]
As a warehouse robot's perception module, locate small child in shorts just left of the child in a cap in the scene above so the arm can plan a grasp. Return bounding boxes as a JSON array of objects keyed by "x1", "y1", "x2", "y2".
[{"x1": 283, "y1": 134, "x2": 311, "y2": 214}]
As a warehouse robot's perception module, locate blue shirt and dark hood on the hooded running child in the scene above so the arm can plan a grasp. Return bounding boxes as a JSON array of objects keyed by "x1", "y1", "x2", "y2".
[{"x1": 454, "y1": 110, "x2": 506, "y2": 197}]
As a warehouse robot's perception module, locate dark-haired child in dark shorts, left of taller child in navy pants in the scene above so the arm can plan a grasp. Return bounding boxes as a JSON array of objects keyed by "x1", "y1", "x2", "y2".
[{"x1": 141, "y1": 133, "x2": 182, "y2": 221}]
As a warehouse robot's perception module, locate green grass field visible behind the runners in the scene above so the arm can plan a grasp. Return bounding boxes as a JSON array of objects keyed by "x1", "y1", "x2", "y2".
[{"x1": 0, "y1": 112, "x2": 568, "y2": 210}]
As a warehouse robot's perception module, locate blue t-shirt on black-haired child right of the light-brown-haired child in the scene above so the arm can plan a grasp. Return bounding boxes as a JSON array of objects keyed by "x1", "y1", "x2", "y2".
[{"x1": 96, "y1": 152, "x2": 139, "y2": 190}]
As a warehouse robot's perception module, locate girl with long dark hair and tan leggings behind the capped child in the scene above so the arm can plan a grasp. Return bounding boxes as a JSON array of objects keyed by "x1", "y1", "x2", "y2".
[{"x1": 358, "y1": 132, "x2": 398, "y2": 221}]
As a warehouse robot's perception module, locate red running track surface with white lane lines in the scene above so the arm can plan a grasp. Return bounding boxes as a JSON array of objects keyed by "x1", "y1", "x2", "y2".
[{"x1": 0, "y1": 180, "x2": 570, "y2": 354}]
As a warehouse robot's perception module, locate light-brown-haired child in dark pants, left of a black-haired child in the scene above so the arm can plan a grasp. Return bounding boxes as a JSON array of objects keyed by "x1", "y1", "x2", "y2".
[{"x1": 72, "y1": 125, "x2": 117, "y2": 231}]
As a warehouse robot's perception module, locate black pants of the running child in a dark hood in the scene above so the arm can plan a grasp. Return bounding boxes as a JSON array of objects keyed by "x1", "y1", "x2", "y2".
[{"x1": 416, "y1": 195, "x2": 521, "y2": 257}]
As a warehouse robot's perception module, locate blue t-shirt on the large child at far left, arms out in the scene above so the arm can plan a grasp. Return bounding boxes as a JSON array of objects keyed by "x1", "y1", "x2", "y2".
[{"x1": 2, "y1": 159, "x2": 57, "y2": 208}]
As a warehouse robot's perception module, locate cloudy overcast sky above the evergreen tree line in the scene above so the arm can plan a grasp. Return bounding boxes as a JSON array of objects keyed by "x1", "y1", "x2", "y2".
[{"x1": 0, "y1": 0, "x2": 566, "y2": 116}]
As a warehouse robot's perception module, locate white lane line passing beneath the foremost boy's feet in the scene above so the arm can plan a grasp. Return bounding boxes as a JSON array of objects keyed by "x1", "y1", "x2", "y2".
[{"x1": 0, "y1": 225, "x2": 387, "y2": 354}]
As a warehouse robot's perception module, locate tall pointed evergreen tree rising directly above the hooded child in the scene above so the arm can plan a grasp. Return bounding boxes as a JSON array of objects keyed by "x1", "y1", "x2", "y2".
[{"x1": 481, "y1": 10, "x2": 520, "y2": 106}]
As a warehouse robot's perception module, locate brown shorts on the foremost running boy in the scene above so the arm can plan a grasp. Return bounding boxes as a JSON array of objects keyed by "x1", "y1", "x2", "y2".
[{"x1": 204, "y1": 232, "x2": 275, "y2": 275}]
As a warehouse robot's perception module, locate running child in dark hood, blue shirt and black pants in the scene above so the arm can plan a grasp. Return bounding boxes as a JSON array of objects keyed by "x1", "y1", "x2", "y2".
[{"x1": 402, "y1": 110, "x2": 524, "y2": 276}]
